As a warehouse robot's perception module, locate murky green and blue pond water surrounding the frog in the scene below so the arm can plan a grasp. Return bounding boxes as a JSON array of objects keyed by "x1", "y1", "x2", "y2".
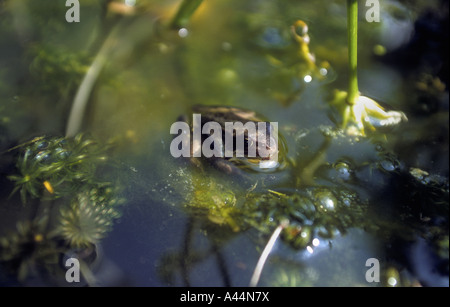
[{"x1": 0, "y1": 0, "x2": 449, "y2": 286}]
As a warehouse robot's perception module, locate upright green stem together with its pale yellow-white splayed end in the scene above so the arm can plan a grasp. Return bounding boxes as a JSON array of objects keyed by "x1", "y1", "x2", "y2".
[{"x1": 330, "y1": 0, "x2": 407, "y2": 136}]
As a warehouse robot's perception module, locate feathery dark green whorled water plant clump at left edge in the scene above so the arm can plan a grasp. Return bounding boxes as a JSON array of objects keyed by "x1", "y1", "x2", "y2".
[{"x1": 0, "y1": 134, "x2": 123, "y2": 280}]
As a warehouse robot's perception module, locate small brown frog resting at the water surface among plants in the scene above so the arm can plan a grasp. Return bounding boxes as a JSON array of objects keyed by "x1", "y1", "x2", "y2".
[{"x1": 179, "y1": 105, "x2": 287, "y2": 177}]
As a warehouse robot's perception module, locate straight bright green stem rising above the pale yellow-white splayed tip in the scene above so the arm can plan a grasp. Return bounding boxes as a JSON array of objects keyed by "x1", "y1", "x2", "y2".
[{"x1": 347, "y1": 0, "x2": 359, "y2": 105}]
